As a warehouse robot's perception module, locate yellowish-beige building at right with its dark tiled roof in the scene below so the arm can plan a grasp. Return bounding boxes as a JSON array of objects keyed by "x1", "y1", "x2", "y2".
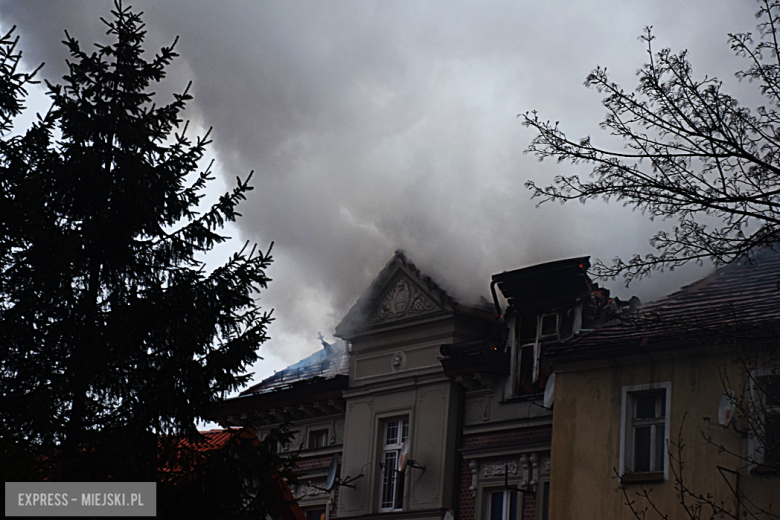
[{"x1": 542, "y1": 252, "x2": 780, "y2": 520}]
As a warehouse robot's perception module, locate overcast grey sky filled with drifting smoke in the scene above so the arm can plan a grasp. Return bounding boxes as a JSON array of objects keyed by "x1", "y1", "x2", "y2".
[{"x1": 0, "y1": 0, "x2": 757, "y2": 386}]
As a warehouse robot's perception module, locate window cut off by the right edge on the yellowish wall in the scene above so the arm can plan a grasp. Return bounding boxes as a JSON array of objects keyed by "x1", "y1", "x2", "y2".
[{"x1": 748, "y1": 370, "x2": 780, "y2": 470}]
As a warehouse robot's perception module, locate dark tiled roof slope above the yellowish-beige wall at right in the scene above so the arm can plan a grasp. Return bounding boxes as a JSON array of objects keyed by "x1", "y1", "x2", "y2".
[{"x1": 544, "y1": 251, "x2": 780, "y2": 363}]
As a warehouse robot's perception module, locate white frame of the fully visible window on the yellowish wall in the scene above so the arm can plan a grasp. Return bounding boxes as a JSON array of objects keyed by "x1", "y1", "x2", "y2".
[{"x1": 619, "y1": 381, "x2": 672, "y2": 480}]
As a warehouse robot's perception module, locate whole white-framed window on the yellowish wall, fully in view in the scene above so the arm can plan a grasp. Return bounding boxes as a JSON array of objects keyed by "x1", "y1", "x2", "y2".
[{"x1": 620, "y1": 382, "x2": 671, "y2": 481}]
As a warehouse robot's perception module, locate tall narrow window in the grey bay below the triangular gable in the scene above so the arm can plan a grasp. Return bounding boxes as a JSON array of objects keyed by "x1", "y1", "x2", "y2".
[{"x1": 379, "y1": 419, "x2": 409, "y2": 511}]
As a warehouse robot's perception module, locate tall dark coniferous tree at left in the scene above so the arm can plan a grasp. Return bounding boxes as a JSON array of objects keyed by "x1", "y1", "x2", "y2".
[{"x1": 0, "y1": 3, "x2": 278, "y2": 494}]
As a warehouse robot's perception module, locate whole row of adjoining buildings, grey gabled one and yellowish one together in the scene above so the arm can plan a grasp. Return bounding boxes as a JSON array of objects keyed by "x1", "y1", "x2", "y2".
[{"x1": 215, "y1": 252, "x2": 780, "y2": 520}]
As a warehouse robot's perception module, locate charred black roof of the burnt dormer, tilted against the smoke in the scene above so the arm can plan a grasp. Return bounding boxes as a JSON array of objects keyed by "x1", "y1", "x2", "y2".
[{"x1": 493, "y1": 256, "x2": 593, "y2": 312}]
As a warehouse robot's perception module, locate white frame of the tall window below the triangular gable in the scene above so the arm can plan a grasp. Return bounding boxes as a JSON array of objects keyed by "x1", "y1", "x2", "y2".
[{"x1": 379, "y1": 415, "x2": 409, "y2": 513}]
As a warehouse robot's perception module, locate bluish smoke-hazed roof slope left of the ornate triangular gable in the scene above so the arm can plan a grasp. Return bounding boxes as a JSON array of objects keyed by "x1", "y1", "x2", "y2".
[{"x1": 240, "y1": 336, "x2": 349, "y2": 395}]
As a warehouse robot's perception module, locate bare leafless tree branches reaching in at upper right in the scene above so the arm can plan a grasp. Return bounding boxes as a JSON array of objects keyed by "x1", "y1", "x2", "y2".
[{"x1": 521, "y1": 0, "x2": 780, "y2": 282}]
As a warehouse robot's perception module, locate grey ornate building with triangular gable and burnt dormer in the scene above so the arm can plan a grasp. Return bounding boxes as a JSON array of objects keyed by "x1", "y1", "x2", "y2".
[{"x1": 210, "y1": 252, "x2": 589, "y2": 520}]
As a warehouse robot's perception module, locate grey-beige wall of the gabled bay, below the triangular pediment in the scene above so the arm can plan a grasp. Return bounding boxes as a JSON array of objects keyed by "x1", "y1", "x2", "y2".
[{"x1": 339, "y1": 313, "x2": 476, "y2": 517}]
